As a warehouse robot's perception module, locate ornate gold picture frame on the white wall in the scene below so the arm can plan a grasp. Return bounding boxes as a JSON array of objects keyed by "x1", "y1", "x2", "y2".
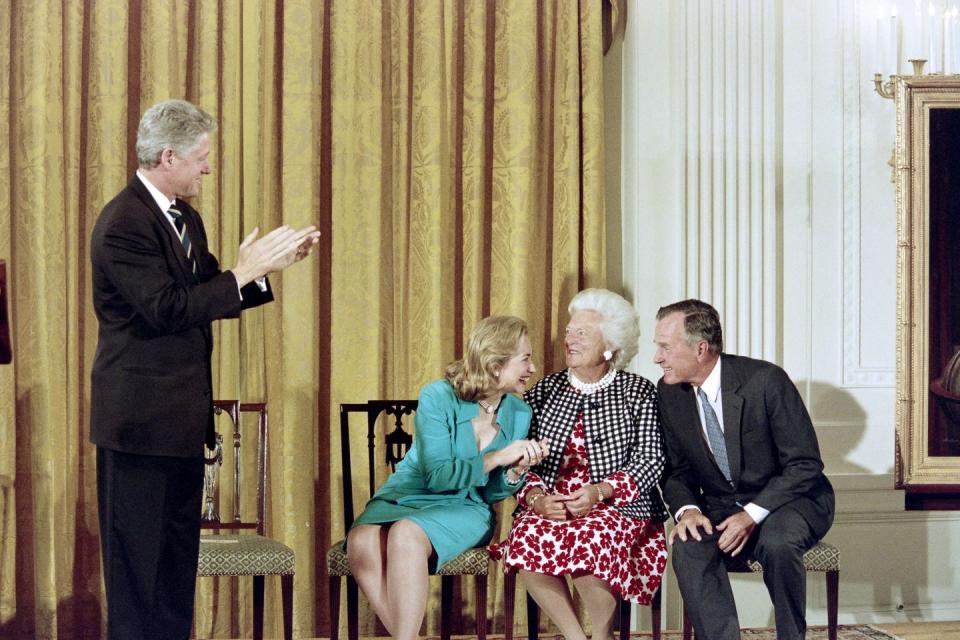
[{"x1": 894, "y1": 76, "x2": 960, "y2": 490}]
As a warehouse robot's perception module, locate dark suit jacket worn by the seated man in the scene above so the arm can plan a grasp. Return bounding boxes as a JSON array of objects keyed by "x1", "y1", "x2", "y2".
[{"x1": 657, "y1": 354, "x2": 834, "y2": 536}]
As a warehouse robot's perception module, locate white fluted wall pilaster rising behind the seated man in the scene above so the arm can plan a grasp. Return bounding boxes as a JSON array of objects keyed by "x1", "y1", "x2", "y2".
[{"x1": 678, "y1": 0, "x2": 783, "y2": 362}]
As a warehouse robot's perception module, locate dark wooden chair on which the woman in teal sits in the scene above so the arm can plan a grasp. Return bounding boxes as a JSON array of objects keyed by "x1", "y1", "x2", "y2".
[{"x1": 327, "y1": 400, "x2": 490, "y2": 640}]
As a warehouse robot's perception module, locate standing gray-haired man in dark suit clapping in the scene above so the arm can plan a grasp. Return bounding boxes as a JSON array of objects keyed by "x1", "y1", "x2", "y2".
[{"x1": 90, "y1": 100, "x2": 320, "y2": 640}]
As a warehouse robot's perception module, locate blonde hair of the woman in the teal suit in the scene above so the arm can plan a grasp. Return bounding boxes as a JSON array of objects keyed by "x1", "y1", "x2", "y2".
[{"x1": 444, "y1": 316, "x2": 527, "y2": 402}]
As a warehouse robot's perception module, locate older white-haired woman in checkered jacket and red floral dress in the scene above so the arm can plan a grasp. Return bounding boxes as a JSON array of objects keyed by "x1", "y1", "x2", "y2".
[{"x1": 491, "y1": 289, "x2": 667, "y2": 640}]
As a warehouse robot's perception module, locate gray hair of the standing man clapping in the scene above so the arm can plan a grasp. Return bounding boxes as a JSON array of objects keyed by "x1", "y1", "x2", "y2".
[{"x1": 137, "y1": 100, "x2": 217, "y2": 169}]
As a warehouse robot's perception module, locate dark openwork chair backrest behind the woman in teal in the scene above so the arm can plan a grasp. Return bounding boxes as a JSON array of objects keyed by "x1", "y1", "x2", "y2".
[{"x1": 340, "y1": 400, "x2": 417, "y2": 530}]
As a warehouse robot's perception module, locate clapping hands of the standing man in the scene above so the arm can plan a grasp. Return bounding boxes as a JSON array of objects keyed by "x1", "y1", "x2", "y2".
[{"x1": 231, "y1": 225, "x2": 320, "y2": 287}]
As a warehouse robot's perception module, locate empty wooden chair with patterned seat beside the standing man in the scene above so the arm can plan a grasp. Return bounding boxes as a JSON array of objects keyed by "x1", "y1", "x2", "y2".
[{"x1": 197, "y1": 400, "x2": 294, "y2": 640}]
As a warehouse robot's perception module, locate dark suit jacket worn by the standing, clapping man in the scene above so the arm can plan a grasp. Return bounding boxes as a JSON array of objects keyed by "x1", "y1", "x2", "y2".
[{"x1": 90, "y1": 176, "x2": 273, "y2": 457}]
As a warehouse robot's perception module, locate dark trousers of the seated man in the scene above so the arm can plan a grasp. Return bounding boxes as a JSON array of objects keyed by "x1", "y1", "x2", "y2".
[{"x1": 673, "y1": 505, "x2": 818, "y2": 640}]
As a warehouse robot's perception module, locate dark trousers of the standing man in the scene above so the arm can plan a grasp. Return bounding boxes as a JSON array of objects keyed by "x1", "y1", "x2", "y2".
[{"x1": 97, "y1": 447, "x2": 203, "y2": 640}]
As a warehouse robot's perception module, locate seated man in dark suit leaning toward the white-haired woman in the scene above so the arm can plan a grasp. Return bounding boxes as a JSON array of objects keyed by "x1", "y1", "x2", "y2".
[{"x1": 654, "y1": 300, "x2": 834, "y2": 640}]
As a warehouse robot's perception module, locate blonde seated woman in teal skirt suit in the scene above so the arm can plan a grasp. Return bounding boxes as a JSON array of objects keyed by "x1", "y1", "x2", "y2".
[{"x1": 347, "y1": 316, "x2": 549, "y2": 639}]
